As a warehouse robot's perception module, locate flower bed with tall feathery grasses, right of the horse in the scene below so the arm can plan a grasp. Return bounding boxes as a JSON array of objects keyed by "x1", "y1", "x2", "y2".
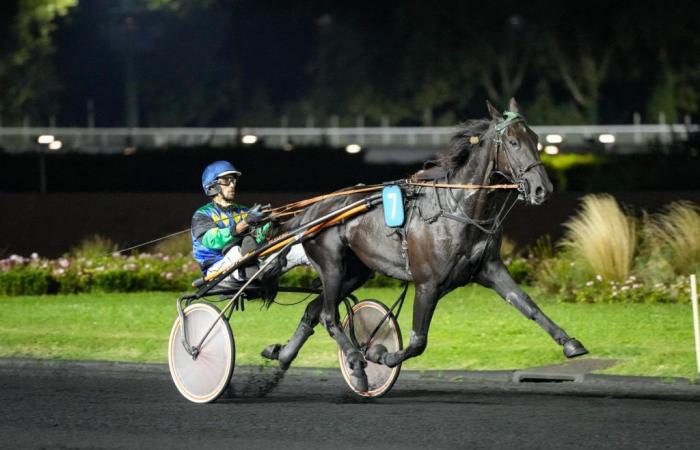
[{"x1": 531, "y1": 195, "x2": 700, "y2": 303}]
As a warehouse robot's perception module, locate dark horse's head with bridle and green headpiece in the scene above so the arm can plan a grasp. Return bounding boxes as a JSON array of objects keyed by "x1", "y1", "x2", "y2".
[{"x1": 486, "y1": 99, "x2": 553, "y2": 205}]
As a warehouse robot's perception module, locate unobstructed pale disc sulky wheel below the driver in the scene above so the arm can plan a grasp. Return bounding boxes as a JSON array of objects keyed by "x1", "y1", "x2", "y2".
[{"x1": 168, "y1": 303, "x2": 236, "y2": 403}]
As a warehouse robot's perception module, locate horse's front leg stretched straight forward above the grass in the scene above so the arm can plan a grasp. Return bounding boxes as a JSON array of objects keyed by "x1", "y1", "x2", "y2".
[{"x1": 476, "y1": 259, "x2": 588, "y2": 358}]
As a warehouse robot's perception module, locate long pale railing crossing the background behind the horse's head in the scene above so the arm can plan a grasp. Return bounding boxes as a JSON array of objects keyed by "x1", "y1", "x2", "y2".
[{"x1": 0, "y1": 124, "x2": 700, "y2": 153}]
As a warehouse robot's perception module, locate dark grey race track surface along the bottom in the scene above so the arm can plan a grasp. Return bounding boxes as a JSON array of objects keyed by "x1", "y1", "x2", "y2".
[{"x1": 0, "y1": 364, "x2": 700, "y2": 449}]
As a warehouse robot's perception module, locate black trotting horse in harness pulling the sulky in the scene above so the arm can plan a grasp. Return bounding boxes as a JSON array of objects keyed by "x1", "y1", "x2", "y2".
[{"x1": 263, "y1": 99, "x2": 588, "y2": 390}]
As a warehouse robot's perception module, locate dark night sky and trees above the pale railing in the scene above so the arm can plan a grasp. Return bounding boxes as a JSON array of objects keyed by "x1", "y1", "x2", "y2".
[{"x1": 0, "y1": 0, "x2": 700, "y2": 126}]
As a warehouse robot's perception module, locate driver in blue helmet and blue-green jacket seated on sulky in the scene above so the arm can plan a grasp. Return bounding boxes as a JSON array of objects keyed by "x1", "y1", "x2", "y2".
[{"x1": 192, "y1": 161, "x2": 309, "y2": 286}]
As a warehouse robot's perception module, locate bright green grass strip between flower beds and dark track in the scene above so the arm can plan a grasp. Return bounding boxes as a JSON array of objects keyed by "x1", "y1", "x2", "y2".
[{"x1": 0, "y1": 287, "x2": 696, "y2": 378}]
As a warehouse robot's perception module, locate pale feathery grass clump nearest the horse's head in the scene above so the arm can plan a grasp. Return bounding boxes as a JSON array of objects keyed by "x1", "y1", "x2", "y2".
[{"x1": 562, "y1": 195, "x2": 636, "y2": 281}]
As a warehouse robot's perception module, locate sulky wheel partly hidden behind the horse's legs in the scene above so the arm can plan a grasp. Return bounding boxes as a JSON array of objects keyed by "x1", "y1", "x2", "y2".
[{"x1": 338, "y1": 300, "x2": 403, "y2": 397}]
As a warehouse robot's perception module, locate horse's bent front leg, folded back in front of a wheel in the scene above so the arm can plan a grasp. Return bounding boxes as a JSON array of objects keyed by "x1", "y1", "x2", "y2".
[{"x1": 367, "y1": 284, "x2": 439, "y2": 367}]
